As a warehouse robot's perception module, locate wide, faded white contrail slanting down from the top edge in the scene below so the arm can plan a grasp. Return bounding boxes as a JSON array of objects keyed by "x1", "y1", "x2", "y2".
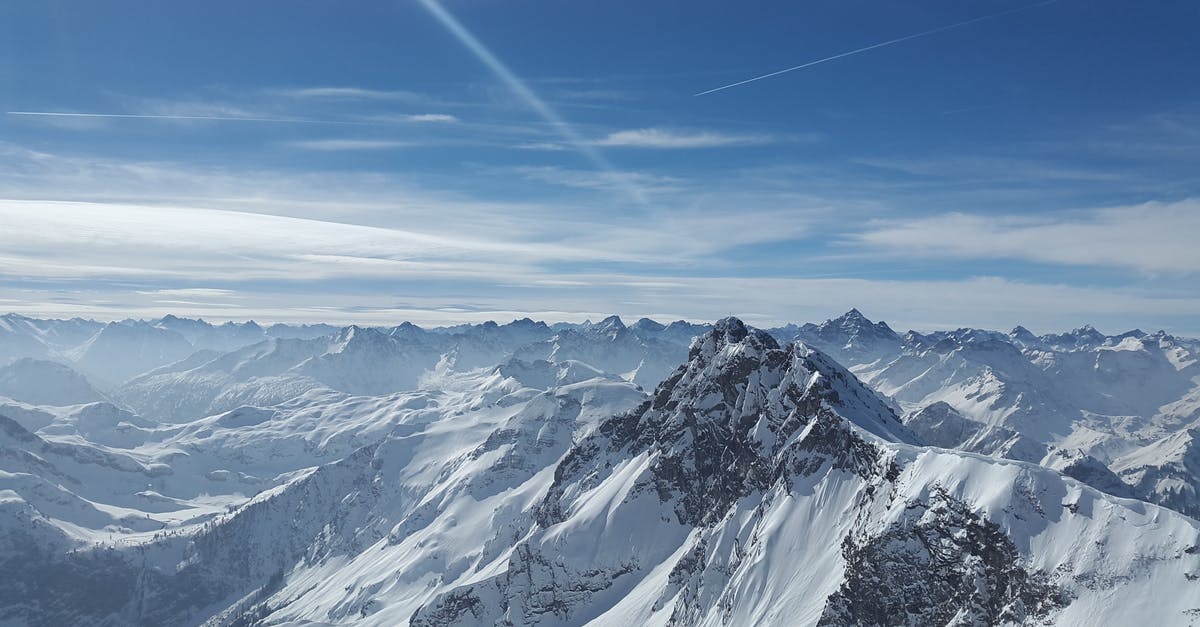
[{"x1": 420, "y1": 0, "x2": 646, "y2": 204}]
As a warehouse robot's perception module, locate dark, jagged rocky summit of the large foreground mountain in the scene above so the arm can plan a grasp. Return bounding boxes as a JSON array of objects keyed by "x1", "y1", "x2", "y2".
[{"x1": 540, "y1": 317, "x2": 914, "y2": 525}]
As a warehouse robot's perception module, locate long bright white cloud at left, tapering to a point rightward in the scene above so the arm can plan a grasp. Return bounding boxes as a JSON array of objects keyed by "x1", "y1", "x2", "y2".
[{"x1": 0, "y1": 201, "x2": 595, "y2": 281}]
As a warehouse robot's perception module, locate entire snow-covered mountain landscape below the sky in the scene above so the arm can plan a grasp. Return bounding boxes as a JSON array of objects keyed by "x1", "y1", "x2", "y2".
[{"x1": 0, "y1": 310, "x2": 1200, "y2": 626}]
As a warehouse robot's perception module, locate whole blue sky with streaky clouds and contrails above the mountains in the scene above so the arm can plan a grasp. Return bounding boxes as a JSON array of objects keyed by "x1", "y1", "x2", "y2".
[{"x1": 0, "y1": 0, "x2": 1200, "y2": 335}]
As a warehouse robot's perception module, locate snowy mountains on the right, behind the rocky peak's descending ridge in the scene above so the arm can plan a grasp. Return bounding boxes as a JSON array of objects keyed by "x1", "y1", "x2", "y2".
[{"x1": 797, "y1": 310, "x2": 1200, "y2": 515}]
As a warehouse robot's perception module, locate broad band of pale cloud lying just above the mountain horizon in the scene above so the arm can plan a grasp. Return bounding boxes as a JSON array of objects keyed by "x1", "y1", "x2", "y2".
[{"x1": 0, "y1": 147, "x2": 1200, "y2": 332}]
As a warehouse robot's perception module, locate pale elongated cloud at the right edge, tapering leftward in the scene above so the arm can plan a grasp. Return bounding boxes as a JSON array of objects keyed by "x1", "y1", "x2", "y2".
[{"x1": 851, "y1": 198, "x2": 1200, "y2": 274}]
